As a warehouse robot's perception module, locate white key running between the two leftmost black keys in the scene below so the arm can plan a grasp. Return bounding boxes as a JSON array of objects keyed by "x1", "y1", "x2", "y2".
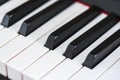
[{"x1": 0, "y1": 0, "x2": 56, "y2": 47}]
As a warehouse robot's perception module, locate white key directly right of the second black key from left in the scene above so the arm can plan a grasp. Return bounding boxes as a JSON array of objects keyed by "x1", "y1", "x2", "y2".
[{"x1": 0, "y1": 3, "x2": 85, "y2": 78}]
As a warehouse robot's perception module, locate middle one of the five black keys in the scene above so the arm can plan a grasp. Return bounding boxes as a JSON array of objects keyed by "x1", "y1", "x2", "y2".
[{"x1": 45, "y1": 6, "x2": 101, "y2": 49}]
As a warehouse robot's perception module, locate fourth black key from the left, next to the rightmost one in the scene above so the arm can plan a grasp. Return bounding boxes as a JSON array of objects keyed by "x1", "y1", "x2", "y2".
[{"x1": 64, "y1": 14, "x2": 119, "y2": 59}]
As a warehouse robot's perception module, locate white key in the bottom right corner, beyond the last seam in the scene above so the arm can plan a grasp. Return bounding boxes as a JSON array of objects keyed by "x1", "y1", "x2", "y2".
[{"x1": 97, "y1": 58, "x2": 120, "y2": 80}]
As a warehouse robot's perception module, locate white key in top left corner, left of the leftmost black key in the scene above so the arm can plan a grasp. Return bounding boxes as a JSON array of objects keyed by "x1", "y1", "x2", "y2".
[{"x1": 0, "y1": 0, "x2": 28, "y2": 23}]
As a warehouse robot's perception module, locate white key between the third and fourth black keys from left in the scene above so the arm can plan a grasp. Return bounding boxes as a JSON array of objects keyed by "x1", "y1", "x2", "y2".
[{"x1": 23, "y1": 12, "x2": 105, "y2": 80}]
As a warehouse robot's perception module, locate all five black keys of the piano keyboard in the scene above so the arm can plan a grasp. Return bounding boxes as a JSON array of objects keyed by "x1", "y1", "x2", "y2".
[{"x1": 2, "y1": 0, "x2": 120, "y2": 69}]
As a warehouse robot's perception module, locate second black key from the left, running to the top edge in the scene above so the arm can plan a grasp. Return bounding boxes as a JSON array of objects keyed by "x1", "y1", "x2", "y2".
[{"x1": 19, "y1": 0, "x2": 74, "y2": 36}]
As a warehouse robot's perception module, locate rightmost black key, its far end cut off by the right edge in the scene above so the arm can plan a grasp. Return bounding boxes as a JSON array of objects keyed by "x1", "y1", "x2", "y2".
[{"x1": 83, "y1": 30, "x2": 120, "y2": 69}]
